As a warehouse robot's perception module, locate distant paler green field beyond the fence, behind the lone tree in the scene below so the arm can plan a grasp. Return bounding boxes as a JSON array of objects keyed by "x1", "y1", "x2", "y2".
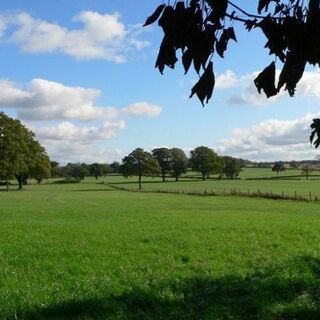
[{"x1": 95, "y1": 168, "x2": 320, "y2": 199}]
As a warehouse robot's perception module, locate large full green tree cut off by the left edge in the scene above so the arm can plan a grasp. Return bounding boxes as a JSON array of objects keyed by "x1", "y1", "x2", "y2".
[{"x1": 0, "y1": 112, "x2": 50, "y2": 190}]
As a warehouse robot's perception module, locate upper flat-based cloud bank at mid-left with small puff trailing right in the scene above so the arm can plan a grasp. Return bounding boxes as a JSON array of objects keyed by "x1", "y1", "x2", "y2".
[{"x1": 0, "y1": 79, "x2": 162, "y2": 121}]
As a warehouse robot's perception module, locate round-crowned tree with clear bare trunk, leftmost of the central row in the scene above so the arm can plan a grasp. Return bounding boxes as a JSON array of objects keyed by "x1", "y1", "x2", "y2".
[{"x1": 120, "y1": 148, "x2": 160, "y2": 189}]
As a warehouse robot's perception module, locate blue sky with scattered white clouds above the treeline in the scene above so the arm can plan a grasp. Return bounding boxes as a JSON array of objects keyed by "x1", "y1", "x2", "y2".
[{"x1": 0, "y1": 0, "x2": 320, "y2": 164}]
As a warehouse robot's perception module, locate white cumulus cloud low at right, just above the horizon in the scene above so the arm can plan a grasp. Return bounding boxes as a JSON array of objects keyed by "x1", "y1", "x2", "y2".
[{"x1": 217, "y1": 114, "x2": 320, "y2": 161}]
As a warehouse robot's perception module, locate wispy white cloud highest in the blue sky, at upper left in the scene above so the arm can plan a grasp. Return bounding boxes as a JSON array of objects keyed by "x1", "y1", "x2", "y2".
[{"x1": 0, "y1": 11, "x2": 150, "y2": 63}]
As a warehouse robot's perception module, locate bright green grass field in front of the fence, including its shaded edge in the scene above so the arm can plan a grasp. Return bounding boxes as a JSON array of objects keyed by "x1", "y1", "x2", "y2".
[{"x1": 0, "y1": 181, "x2": 320, "y2": 320}]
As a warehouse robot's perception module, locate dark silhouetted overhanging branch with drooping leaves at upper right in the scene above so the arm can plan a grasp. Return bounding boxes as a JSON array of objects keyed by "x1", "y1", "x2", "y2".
[{"x1": 144, "y1": 0, "x2": 320, "y2": 148}]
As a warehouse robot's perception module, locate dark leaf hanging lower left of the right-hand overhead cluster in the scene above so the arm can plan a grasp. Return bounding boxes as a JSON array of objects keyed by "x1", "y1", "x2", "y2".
[{"x1": 254, "y1": 62, "x2": 278, "y2": 98}]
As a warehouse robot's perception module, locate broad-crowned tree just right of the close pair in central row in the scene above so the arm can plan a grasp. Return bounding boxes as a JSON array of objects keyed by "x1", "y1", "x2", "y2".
[{"x1": 190, "y1": 146, "x2": 224, "y2": 181}]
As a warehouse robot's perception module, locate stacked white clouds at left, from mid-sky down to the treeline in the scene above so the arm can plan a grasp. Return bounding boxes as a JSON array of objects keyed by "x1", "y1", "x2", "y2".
[{"x1": 0, "y1": 79, "x2": 162, "y2": 163}]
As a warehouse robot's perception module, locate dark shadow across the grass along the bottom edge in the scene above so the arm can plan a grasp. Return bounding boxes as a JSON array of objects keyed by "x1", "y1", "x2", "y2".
[{"x1": 10, "y1": 257, "x2": 320, "y2": 320}]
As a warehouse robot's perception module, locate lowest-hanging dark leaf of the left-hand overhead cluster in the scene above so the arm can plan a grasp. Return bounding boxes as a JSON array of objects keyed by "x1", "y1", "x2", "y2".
[{"x1": 190, "y1": 61, "x2": 215, "y2": 106}]
